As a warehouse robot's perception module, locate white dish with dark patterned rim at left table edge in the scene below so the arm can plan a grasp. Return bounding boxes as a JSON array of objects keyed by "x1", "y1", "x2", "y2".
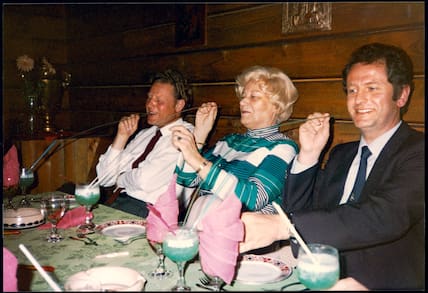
[{"x1": 3, "y1": 208, "x2": 45, "y2": 229}]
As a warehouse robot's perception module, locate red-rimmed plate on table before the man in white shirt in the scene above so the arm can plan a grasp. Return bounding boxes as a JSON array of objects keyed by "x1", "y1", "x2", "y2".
[{"x1": 95, "y1": 220, "x2": 146, "y2": 240}]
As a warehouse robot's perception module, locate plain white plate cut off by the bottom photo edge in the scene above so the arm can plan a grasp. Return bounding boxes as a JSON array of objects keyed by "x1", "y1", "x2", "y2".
[{"x1": 64, "y1": 266, "x2": 146, "y2": 292}]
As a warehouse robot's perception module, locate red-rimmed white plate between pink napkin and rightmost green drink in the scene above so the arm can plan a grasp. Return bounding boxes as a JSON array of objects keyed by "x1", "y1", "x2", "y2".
[{"x1": 236, "y1": 254, "x2": 293, "y2": 285}]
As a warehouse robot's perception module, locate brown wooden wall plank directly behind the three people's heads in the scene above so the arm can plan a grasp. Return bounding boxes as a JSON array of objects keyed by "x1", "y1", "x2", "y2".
[{"x1": 67, "y1": 28, "x2": 425, "y2": 85}]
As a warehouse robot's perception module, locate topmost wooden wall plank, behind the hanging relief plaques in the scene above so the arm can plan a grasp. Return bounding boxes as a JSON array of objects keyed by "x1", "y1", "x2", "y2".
[{"x1": 68, "y1": 2, "x2": 424, "y2": 60}]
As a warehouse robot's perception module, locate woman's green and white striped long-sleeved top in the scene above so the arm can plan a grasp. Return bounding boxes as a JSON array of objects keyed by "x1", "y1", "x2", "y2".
[{"x1": 175, "y1": 125, "x2": 298, "y2": 214}]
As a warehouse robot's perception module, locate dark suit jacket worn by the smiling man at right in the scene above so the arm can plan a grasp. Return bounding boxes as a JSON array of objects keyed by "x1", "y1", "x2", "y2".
[{"x1": 283, "y1": 122, "x2": 425, "y2": 289}]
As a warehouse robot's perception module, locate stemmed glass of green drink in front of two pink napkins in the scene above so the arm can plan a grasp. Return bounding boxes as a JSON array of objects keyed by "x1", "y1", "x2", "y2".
[{"x1": 162, "y1": 225, "x2": 199, "y2": 291}]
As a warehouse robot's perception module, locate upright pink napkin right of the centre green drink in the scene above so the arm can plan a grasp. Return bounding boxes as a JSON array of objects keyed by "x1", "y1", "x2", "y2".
[{"x1": 199, "y1": 195, "x2": 244, "y2": 284}]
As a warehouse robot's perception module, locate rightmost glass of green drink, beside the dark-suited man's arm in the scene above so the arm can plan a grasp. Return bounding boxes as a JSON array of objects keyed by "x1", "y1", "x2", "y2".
[{"x1": 297, "y1": 243, "x2": 339, "y2": 290}]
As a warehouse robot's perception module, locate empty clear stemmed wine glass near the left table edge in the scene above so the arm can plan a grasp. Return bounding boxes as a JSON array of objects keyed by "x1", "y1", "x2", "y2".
[{"x1": 40, "y1": 194, "x2": 67, "y2": 243}]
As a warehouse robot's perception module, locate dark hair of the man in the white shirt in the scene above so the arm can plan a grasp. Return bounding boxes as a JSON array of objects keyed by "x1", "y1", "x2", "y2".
[{"x1": 150, "y1": 69, "x2": 193, "y2": 109}]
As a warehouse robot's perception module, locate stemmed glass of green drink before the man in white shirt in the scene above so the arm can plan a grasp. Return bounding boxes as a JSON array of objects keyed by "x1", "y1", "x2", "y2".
[{"x1": 74, "y1": 183, "x2": 100, "y2": 234}]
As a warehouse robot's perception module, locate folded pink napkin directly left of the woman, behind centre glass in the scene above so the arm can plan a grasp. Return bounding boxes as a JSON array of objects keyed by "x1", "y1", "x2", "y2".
[{"x1": 146, "y1": 173, "x2": 178, "y2": 243}]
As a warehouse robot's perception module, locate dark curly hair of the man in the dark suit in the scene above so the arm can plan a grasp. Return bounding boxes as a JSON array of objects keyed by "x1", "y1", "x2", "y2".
[{"x1": 342, "y1": 43, "x2": 415, "y2": 115}]
